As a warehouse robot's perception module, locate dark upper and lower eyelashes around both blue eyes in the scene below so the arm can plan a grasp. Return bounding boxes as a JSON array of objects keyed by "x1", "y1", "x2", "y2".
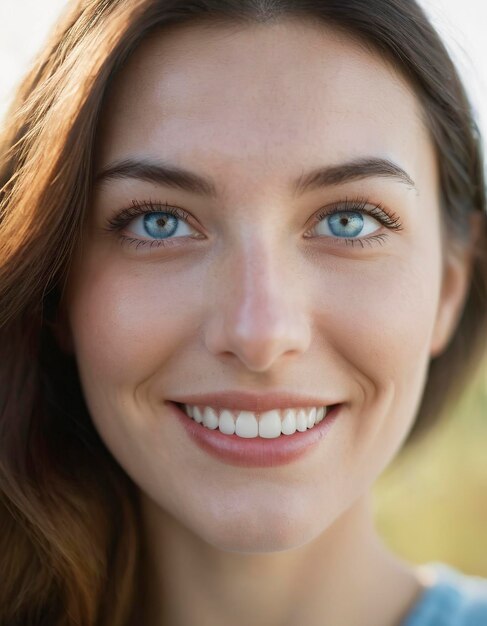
[{"x1": 105, "y1": 198, "x2": 402, "y2": 249}]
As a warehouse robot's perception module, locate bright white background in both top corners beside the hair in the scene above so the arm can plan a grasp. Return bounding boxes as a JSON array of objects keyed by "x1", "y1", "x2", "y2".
[{"x1": 0, "y1": 0, "x2": 487, "y2": 147}]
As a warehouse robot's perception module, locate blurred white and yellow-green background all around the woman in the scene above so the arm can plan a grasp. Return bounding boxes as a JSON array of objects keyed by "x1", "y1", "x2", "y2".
[{"x1": 0, "y1": 0, "x2": 487, "y2": 577}]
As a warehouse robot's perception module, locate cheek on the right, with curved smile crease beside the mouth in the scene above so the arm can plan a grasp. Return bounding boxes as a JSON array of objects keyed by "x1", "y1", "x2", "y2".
[{"x1": 310, "y1": 241, "x2": 441, "y2": 446}]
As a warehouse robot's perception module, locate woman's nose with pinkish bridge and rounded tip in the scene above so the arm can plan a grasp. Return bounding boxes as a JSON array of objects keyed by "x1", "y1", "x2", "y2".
[{"x1": 206, "y1": 243, "x2": 311, "y2": 372}]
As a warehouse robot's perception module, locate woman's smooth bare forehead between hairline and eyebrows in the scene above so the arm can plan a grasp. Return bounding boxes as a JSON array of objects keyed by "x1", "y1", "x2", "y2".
[{"x1": 97, "y1": 19, "x2": 435, "y2": 193}]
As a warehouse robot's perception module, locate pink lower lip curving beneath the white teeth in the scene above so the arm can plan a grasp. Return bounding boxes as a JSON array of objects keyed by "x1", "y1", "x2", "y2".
[{"x1": 167, "y1": 402, "x2": 342, "y2": 467}]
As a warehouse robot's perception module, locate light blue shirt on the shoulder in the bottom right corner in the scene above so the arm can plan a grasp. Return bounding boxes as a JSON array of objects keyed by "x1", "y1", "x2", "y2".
[{"x1": 401, "y1": 562, "x2": 487, "y2": 626}]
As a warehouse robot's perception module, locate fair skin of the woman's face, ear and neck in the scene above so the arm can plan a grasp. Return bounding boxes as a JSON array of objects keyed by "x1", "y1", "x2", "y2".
[{"x1": 60, "y1": 20, "x2": 469, "y2": 626}]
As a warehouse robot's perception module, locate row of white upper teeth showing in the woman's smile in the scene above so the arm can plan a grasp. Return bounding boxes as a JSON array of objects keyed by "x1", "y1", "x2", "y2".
[{"x1": 184, "y1": 404, "x2": 328, "y2": 439}]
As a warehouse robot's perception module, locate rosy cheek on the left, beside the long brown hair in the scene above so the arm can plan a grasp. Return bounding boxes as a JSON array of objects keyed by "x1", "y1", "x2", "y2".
[{"x1": 68, "y1": 260, "x2": 201, "y2": 396}]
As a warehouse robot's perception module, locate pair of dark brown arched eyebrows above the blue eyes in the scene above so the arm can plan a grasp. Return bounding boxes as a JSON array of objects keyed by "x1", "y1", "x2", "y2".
[{"x1": 95, "y1": 157, "x2": 416, "y2": 198}]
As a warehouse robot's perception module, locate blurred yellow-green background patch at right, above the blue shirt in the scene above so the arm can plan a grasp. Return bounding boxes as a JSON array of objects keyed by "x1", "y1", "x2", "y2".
[{"x1": 373, "y1": 364, "x2": 487, "y2": 578}]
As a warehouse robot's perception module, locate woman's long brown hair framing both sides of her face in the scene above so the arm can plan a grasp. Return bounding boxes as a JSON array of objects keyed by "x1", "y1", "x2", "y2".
[{"x1": 0, "y1": 0, "x2": 487, "y2": 626}]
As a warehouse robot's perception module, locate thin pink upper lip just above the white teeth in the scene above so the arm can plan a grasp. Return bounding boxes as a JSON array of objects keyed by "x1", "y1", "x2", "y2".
[{"x1": 171, "y1": 391, "x2": 336, "y2": 412}]
